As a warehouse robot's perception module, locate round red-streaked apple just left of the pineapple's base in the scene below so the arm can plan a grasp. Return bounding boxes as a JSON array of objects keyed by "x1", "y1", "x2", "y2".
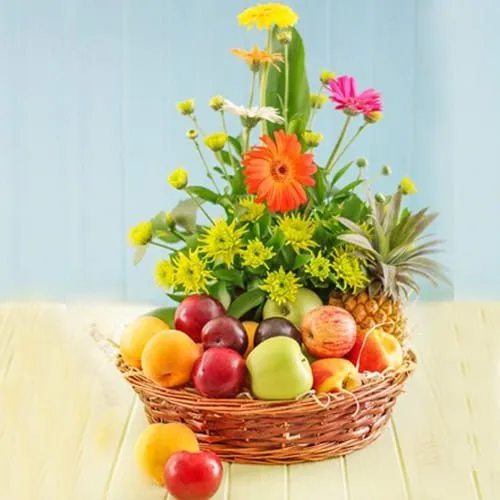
[{"x1": 302, "y1": 306, "x2": 356, "y2": 358}]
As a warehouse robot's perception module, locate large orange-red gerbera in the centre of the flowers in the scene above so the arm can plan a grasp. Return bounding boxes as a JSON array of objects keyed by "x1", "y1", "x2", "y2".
[{"x1": 243, "y1": 130, "x2": 317, "y2": 212}]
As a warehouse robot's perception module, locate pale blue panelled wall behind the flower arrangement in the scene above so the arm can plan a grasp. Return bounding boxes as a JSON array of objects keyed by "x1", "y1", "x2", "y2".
[{"x1": 0, "y1": 0, "x2": 500, "y2": 301}]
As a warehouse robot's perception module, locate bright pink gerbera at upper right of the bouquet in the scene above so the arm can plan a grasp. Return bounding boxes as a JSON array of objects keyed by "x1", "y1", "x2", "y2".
[{"x1": 326, "y1": 76, "x2": 382, "y2": 116}]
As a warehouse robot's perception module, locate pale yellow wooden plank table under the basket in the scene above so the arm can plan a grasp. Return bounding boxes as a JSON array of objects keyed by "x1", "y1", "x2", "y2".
[{"x1": 0, "y1": 303, "x2": 500, "y2": 500}]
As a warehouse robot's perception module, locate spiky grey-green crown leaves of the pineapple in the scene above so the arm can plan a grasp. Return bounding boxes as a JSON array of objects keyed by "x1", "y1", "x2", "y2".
[{"x1": 337, "y1": 189, "x2": 450, "y2": 300}]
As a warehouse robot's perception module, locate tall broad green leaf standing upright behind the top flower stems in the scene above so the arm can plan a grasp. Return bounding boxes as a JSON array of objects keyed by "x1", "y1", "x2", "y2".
[{"x1": 261, "y1": 26, "x2": 311, "y2": 135}]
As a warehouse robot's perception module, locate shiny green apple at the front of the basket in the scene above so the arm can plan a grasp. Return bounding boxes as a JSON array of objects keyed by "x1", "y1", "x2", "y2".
[{"x1": 247, "y1": 337, "x2": 313, "y2": 401}]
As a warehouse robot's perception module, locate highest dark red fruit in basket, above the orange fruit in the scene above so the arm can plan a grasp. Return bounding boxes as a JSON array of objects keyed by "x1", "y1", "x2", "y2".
[{"x1": 175, "y1": 295, "x2": 226, "y2": 342}]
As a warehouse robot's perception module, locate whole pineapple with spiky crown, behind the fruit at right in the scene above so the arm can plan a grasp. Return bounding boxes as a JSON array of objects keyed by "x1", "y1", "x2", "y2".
[{"x1": 329, "y1": 188, "x2": 448, "y2": 339}]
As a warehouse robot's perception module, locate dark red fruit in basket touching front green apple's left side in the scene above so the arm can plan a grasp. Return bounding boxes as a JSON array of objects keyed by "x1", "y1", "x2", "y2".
[{"x1": 192, "y1": 347, "x2": 246, "y2": 398}]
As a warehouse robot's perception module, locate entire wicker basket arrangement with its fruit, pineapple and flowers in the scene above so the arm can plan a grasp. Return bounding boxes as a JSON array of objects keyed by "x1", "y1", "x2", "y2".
[{"x1": 112, "y1": 0, "x2": 446, "y2": 463}]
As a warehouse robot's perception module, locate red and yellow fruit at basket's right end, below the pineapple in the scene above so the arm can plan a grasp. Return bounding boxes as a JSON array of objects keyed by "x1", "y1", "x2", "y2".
[{"x1": 347, "y1": 328, "x2": 403, "y2": 372}]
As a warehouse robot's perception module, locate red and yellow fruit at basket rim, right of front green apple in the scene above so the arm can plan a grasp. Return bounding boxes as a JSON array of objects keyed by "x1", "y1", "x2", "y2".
[{"x1": 311, "y1": 358, "x2": 361, "y2": 394}]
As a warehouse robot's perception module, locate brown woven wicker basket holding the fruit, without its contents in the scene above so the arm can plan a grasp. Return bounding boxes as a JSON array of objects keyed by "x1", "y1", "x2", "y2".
[{"x1": 116, "y1": 350, "x2": 416, "y2": 464}]
